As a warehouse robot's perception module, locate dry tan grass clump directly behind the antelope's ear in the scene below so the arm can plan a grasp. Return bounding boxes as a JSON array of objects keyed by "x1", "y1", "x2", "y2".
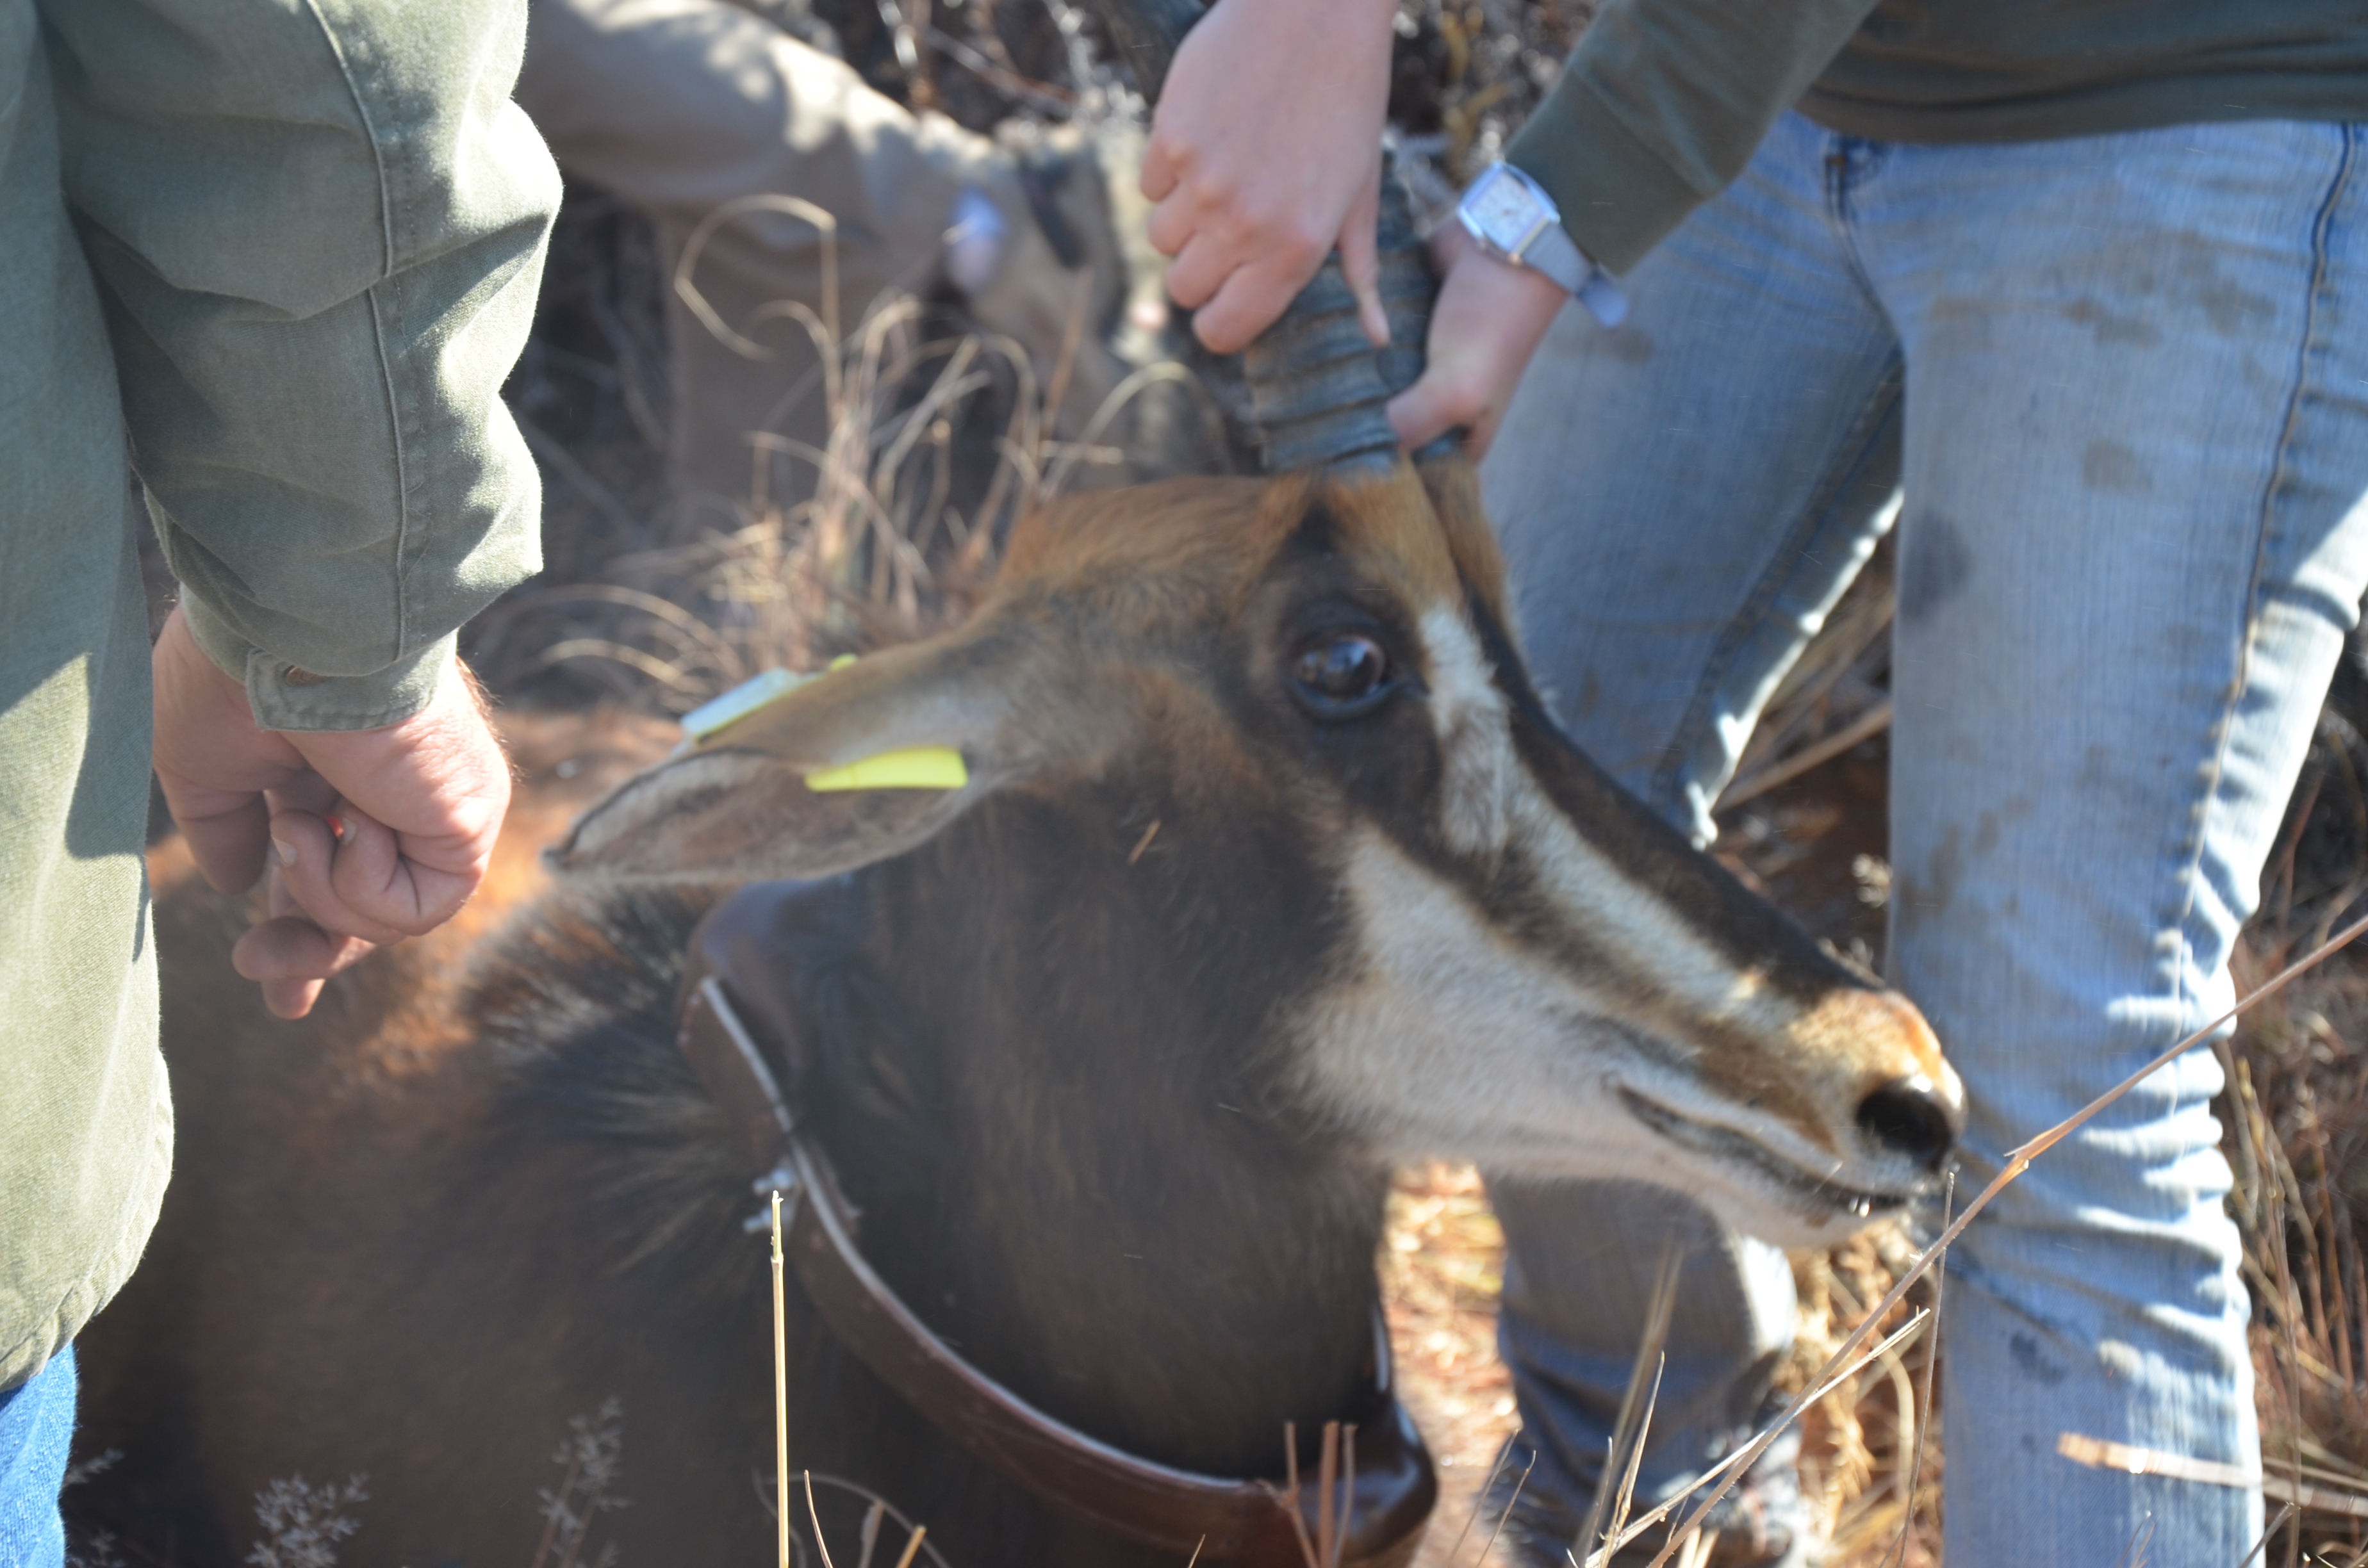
[{"x1": 469, "y1": 170, "x2": 1224, "y2": 713}]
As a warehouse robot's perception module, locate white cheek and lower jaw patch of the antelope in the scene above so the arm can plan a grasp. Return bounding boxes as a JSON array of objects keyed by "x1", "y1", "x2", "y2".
[{"x1": 1293, "y1": 834, "x2": 1854, "y2": 1241}]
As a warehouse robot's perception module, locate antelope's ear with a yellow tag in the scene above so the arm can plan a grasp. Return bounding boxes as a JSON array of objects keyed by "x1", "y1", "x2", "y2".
[{"x1": 547, "y1": 635, "x2": 1056, "y2": 883}]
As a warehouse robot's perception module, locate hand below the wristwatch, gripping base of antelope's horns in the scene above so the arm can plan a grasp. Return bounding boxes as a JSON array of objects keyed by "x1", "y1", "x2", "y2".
[{"x1": 1388, "y1": 220, "x2": 1570, "y2": 462}]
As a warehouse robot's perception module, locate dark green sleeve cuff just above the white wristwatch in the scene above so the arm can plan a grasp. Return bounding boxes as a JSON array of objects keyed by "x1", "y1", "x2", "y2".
[{"x1": 1504, "y1": 71, "x2": 1717, "y2": 272}]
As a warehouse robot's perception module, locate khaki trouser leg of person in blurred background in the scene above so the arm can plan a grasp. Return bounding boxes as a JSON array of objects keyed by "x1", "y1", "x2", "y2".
[{"x1": 518, "y1": 0, "x2": 997, "y2": 502}]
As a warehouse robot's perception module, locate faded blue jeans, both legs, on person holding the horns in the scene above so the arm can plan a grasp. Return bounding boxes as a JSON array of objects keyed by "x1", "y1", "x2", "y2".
[{"x1": 1483, "y1": 116, "x2": 2368, "y2": 1568}]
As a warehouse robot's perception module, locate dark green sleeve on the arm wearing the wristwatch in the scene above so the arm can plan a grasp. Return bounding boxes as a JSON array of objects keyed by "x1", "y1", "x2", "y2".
[{"x1": 1506, "y1": 0, "x2": 1875, "y2": 272}]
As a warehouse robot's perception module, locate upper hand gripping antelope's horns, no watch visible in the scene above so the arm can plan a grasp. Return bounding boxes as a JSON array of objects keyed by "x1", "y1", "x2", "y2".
[{"x1": 1141, "y1": 0, "x2": 1397, "y2": 353}]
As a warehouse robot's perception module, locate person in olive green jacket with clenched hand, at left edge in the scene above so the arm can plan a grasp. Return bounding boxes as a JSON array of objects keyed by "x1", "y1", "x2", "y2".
[{"x1": 0, "y1": 0, "x2": 559, "y2": 1565}]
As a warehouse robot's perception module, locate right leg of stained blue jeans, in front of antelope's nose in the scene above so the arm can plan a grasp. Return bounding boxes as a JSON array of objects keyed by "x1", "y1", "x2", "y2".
[{"x1": 1850, "y1": 123, "x2": 2368, "y2": 1568}]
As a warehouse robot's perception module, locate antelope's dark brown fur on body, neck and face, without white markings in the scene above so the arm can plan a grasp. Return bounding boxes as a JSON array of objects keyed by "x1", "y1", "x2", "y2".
[{"x1": 85, "y1": 474, "x2": 1941, "y2": 1568}]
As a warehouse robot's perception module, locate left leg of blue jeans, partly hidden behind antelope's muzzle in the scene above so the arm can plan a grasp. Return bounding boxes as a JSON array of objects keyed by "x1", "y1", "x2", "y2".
[{"x1": 1483, "y1": 121, "x2": 1899, "y2": 1561}]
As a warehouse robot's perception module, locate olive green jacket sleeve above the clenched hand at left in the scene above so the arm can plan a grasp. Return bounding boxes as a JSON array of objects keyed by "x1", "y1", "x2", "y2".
[{"x1": 43, "y1": 0, "x2": 559, "y2": 730}]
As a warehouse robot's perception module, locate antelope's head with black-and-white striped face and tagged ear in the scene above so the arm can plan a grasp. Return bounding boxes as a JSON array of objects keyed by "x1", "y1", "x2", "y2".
[{"x1": 552, "y1": 457, "x2": 1961, "y2": 1243}]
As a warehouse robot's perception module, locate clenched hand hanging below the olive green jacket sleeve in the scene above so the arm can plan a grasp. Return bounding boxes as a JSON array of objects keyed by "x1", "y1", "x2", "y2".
[{"x1": 154, "y1": 608, "x2": 509, "y2": 1018}]
